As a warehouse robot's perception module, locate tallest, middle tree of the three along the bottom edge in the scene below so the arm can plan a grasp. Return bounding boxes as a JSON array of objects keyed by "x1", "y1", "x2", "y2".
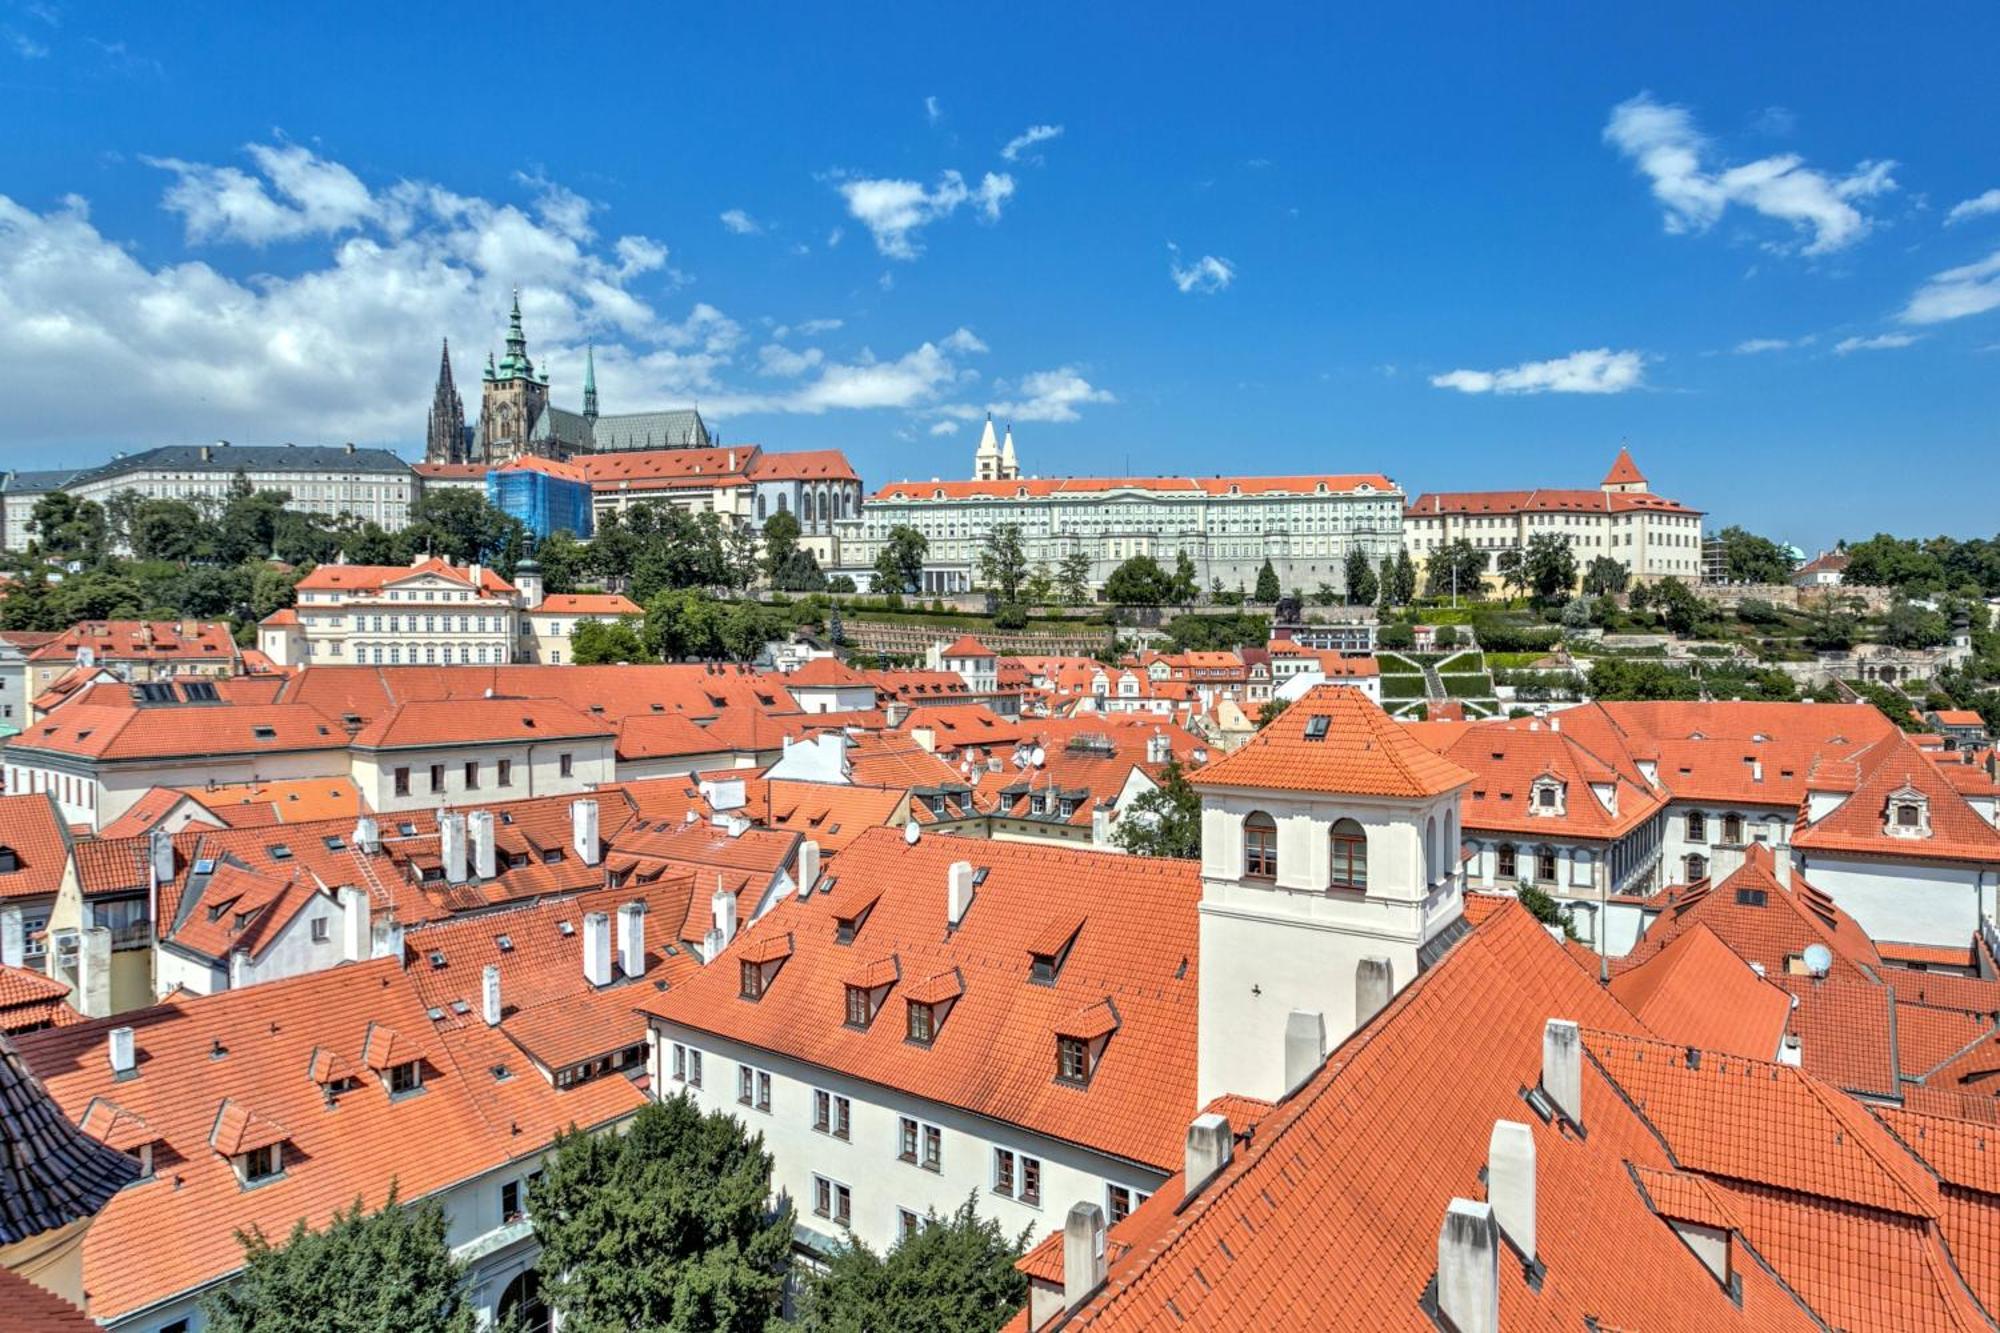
[{"x1": 528, "y1": 1097, "x2": 792, "y2": 1333}]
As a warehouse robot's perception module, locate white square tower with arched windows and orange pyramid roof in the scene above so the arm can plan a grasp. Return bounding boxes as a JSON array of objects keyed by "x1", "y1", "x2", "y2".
[{"x1": 1190, "y1": 685, "x2": 1472, "y2": 1105}]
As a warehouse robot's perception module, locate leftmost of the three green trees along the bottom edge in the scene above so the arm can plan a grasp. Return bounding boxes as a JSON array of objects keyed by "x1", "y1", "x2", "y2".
[{"x1": 202, "y1": 1191, "x2": 476, "y2": 1333}]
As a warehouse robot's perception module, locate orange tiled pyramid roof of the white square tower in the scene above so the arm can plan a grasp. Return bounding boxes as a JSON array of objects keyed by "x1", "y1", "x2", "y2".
[{"x1": 1188, "y1": 685, "x2": 1472, "y2": 797}]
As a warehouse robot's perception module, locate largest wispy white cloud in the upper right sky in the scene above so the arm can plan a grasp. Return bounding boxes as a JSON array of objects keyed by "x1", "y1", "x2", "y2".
[{"x1": 1604, "y1": 92, "x2": 1896, "y2": 254}]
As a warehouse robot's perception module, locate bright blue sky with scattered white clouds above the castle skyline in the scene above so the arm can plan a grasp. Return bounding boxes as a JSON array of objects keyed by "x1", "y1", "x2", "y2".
[{"x1": 0, "y1": 0, "x2": 2000, "y2": 546}]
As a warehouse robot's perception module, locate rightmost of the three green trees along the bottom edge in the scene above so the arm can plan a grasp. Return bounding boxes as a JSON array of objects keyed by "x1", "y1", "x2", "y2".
[{"x1": 800, "y1": 1195, "x2": 1028, "y2": 1333}]
